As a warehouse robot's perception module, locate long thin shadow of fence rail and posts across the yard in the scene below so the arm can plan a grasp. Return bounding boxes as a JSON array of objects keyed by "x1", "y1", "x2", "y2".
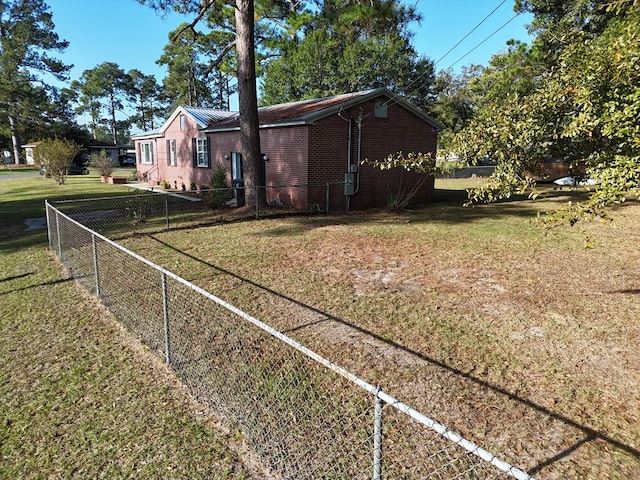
[{"x1": 150, "y1": 235, "x2": 640, "y2": 475}]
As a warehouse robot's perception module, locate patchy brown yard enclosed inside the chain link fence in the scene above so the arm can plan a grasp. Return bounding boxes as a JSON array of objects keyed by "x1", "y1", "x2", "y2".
[{"x1": 124, "y1": 185, "x2": 640, "y2": 479}]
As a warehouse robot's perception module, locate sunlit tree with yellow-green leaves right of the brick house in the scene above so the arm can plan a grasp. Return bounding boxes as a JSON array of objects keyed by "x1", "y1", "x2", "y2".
[{"x1": 455, "y1": 3, "x2": 640, "y2": 224}]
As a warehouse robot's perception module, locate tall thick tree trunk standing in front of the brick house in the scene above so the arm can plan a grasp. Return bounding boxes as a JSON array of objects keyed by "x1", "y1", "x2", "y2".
[{"x1": 235, "y1": 0, "x2": 267, "y2": 208}]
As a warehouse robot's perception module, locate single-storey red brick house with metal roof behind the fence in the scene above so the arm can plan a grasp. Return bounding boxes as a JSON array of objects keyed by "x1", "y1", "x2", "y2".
[{"x1": 133, "y1": 89, "x2": 442, "y2": 210}]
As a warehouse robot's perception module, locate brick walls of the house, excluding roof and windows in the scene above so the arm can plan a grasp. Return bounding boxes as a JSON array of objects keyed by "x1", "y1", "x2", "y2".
[{"x1": 136, "y1": 100, "x2": 437, "y2": 211}]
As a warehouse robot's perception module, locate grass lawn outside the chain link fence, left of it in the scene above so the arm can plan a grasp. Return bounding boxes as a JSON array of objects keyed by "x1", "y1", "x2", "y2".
[{"x1": 0, "y1": 175, "x2": 255, "y2": 479}]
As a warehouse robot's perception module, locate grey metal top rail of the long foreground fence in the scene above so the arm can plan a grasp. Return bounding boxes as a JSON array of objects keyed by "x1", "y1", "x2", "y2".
[{"x1": 45, "y1": 197, "x2": 535, "y2": 480}]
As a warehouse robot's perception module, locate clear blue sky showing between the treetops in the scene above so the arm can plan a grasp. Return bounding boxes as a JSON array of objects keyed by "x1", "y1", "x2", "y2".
[{"x1": 45, "y1": 0, "x2": 531, "y2": 108}]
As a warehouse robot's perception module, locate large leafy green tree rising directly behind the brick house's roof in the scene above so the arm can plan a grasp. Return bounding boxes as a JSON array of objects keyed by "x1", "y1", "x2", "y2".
[{"x1": 261, "y1": 0, "x2": 435, "y2": 110}]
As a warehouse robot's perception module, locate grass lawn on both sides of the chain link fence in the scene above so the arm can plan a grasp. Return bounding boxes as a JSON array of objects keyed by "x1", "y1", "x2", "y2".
[{"x1": 6, "y1": 174, "x2": 640, "y2": 479}]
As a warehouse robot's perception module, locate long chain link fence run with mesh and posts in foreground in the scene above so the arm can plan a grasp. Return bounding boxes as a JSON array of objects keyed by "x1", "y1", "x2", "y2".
[{"x1": 46, "y1": 194, "x2": 532, "y2": 480}]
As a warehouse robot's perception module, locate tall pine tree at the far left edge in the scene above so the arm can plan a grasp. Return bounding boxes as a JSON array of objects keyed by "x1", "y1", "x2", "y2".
[{"x1": 0, "y1": 0, "x2": 70, "y2": 163}]
